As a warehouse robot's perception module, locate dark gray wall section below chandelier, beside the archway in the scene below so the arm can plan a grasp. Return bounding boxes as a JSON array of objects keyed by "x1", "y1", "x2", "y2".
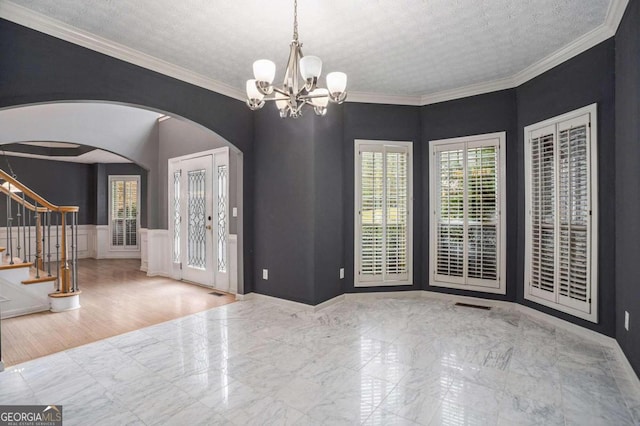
[{"x1": 254, "y1": 108, "x2": 316, "y2": 304}]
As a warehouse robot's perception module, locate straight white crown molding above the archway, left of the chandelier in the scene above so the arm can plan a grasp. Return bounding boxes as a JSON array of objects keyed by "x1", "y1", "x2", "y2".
[{"x1": 0, "y1": 1, "x2": 245, "y2": 101}]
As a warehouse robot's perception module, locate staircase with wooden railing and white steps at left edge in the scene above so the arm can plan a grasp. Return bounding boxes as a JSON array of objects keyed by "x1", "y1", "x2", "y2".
[{"x1": 0, "y1": 170, "x2": 80, "y2": 319}]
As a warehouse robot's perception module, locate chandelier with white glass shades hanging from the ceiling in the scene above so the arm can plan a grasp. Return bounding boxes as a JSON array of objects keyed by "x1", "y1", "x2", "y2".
[{"x1": 246, "y1": 0, "x2": 347, "y2": 118}]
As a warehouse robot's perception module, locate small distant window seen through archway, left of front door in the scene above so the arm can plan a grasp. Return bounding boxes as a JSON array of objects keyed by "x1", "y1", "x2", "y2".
[{"x1": 109, "y1": 176, "x2": 140, "y2": 250}]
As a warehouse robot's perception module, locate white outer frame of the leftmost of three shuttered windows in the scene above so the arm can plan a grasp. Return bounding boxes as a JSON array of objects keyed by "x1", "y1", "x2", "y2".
[{"x1": 353, "y1": 139, "x2": 414, "y2": 288}]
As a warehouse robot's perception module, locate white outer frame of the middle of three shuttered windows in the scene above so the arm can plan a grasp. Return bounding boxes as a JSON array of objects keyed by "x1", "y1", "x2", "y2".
[{"x1": 428, "y1": 132, "x2": 507, "y2": 294}]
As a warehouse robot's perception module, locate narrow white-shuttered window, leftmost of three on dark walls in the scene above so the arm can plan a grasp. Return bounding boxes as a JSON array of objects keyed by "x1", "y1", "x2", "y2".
[{"x1": 354, "y1": 140, "x2": 413, "y2": 287}]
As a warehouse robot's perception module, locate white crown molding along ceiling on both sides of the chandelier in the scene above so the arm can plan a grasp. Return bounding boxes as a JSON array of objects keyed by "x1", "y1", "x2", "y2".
[{"x1": 0, "y1": 0, "x2": 629, "y2": 106}]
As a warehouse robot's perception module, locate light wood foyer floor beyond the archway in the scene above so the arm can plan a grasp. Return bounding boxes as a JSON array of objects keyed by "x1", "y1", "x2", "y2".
[{"x1": 2, "y1": 259, "x2": 235, "y2": 365}]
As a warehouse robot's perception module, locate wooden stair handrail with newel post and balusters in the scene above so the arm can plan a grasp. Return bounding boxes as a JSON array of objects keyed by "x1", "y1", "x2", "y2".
[{"x1": 0, "y1": 169, "x2": 80, "y2": 294}]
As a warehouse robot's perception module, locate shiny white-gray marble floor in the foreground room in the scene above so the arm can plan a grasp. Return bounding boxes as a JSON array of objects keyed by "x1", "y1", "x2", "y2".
[{"x1": 0, "y1": 297, "x2": 640, "y2": 425}]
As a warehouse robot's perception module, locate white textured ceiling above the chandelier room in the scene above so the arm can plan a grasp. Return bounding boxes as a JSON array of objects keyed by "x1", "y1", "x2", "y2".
[{"x1": 6, "y1": 0, "x2": 612, "y2": 96}]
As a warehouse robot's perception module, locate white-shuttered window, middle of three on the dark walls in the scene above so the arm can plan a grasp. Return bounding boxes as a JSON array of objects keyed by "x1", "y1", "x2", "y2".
[{"x1": 429, "y1": 132, "x2": 506, "y2": 294}]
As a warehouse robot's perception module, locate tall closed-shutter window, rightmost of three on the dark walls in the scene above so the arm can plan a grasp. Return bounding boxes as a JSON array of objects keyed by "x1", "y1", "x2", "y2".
[{"x1": 524, "y1": 104, "x2": 598, "y2": 322}]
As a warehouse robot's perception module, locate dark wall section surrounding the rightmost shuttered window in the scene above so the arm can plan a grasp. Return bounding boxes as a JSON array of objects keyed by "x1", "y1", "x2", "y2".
[{"x1": 511, "y1": 38, "x2": 616, "y2": 336}]
